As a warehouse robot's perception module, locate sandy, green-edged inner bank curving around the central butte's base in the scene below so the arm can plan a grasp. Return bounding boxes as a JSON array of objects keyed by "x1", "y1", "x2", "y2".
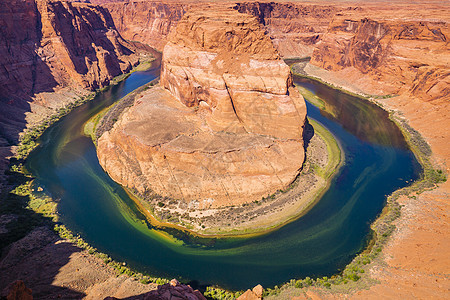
[{"x1": 84, "y1": 80, "x2": 344, "y2": 238}]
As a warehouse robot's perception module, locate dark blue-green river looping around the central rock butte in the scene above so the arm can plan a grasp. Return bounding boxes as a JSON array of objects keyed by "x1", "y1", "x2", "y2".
[{"x1": 26, "y1": 70, "x2": 421, "y2": 290}]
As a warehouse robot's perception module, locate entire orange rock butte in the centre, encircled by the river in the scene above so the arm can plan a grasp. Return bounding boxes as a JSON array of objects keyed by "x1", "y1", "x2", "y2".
[{"x1": 97, "y1": 9, "x2": 306, "y2": 208}]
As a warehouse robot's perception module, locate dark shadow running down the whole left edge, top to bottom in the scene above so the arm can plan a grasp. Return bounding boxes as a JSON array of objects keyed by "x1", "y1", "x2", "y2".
[{"x1": 0, "y1": 8, "x2": 62, "y2": 299}]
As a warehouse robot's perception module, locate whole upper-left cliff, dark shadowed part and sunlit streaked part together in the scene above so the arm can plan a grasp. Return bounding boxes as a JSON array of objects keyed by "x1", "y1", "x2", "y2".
[{"x1": 0, "y1": 0, "x2": 146, "y2": 145}]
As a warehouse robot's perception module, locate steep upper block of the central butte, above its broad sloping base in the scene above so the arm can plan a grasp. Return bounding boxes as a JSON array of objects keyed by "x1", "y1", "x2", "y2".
[{"x1": 161, "y1": 9, "x2": 306, "y2": 140}]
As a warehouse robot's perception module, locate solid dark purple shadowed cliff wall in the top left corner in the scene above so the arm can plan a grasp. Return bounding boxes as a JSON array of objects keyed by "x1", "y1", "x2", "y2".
[{"x1": 0, "y1": 1, "x2": 57, "y2": 148}]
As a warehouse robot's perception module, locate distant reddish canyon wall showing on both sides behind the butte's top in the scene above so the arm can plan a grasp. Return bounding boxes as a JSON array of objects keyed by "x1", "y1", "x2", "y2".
[{"x1": 97, "y1": 0, "x2": 341, "y2": 57}]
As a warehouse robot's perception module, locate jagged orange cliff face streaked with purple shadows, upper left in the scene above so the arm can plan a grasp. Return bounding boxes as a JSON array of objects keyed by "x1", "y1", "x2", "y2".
[{"x1": 37, "y1": 0, "x2": 138, "y2": 89}]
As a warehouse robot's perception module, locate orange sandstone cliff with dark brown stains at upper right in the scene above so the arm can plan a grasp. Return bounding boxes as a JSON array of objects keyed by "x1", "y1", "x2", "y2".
[{"x1": 311, "y1": 11, "x2": 450, "y2": 101}]
